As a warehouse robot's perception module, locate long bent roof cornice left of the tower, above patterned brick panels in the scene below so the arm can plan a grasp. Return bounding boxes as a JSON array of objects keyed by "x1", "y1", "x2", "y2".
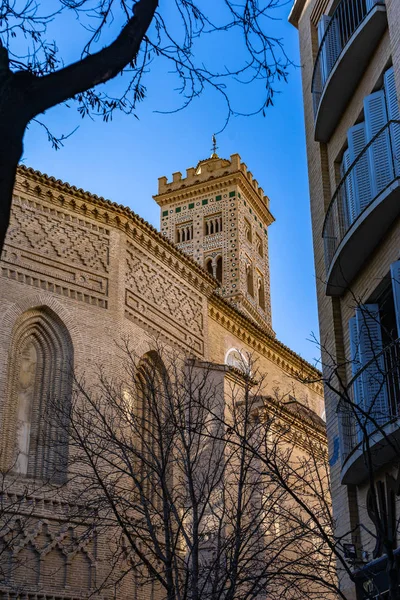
[{"x1": 14, "y1": 165, "x2": 218, "y2": 296}]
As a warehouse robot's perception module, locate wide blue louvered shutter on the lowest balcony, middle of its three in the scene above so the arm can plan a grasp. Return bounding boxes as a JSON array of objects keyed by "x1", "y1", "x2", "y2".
[{"x1": 356, "y1": 304, "x2": 389, "y2": 431}]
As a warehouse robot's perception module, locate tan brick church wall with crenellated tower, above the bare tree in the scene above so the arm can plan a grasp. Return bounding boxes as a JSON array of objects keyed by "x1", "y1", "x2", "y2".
[{"x1": 0, "y1": 155, "x2": 324, "y2": 599}]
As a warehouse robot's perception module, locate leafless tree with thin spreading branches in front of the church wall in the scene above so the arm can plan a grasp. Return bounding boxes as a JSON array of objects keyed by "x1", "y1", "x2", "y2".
[{"x1": 53, "y1": 346, "x2": 354, "y2": 600}]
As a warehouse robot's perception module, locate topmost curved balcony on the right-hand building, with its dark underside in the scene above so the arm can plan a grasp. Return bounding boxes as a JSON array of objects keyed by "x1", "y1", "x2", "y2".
[{"x1": 311, "y1": 0, "x2": 387, "y2": 142}]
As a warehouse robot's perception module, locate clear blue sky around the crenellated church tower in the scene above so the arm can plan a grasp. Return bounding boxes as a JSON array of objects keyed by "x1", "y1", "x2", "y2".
[{"x1": 22, "y1": 4, "x2": 319, "y2": 362}]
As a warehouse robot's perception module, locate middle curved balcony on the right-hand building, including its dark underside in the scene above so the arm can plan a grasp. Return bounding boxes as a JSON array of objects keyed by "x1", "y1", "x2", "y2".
[{"x1": 322, "y1": 121, "x2": 400, "y2": 296}]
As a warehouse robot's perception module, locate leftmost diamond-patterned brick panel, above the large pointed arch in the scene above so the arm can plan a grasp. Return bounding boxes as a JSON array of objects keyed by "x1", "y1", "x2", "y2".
[{"x1": 1, "y1": 197, "x2": 109, "y2": 308}]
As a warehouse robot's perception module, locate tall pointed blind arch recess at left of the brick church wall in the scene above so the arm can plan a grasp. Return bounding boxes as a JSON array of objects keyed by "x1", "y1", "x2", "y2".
[{"x1": 3, "y1": 308, "x2": 73, "y2": 483}]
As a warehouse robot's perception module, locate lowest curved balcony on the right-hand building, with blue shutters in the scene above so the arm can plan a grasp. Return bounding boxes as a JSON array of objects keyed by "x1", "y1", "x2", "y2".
[{"x1": 338, "y1": 339, "x2": 400, "y2": 485}]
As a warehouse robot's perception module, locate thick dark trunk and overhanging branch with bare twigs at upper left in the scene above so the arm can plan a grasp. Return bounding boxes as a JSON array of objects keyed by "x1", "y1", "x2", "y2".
[{"x1": 0, "y1": 0, "x2": 290, "y2": 252}]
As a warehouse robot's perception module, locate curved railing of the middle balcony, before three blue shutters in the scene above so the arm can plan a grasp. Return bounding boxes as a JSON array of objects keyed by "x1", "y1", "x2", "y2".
[{"x1": 322, "y1": 121, "x2": 400, "y2": 282}]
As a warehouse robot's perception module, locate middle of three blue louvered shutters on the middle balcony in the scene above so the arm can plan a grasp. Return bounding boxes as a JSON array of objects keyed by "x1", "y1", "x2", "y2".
[{"x1": 364, "y1": 90, "x2": 393, "y2": 198}]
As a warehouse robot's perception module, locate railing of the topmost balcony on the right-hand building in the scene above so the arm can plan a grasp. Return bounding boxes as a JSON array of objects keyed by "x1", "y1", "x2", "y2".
[{"x1": 311, "y1": 0, "x2": 385, "y2": 126}]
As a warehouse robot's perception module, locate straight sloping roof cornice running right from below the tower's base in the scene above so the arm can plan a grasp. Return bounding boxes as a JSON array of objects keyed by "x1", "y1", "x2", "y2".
[{"x1": 209, "y1": 293, "x2": 323, "y2": 396}]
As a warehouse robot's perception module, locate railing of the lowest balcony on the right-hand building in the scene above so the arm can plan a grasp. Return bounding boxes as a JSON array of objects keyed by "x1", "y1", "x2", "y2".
[{"x1": 338, "y1": 338, "x2": 400, "y2": 463}]
